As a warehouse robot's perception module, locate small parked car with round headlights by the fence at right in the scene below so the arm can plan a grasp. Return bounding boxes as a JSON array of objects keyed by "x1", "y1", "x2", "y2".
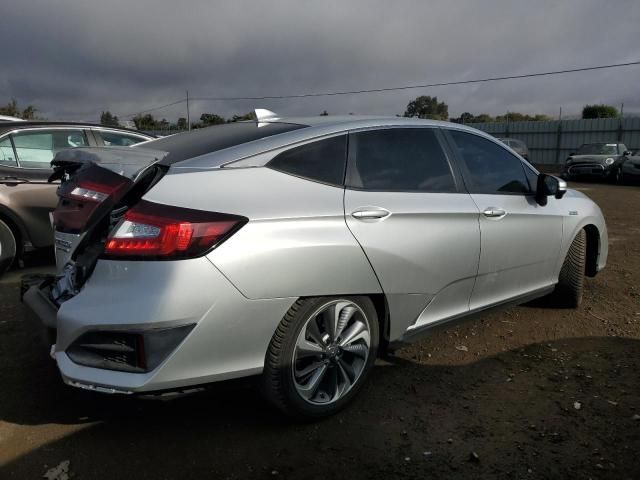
[{"x1": 562, "y1": 143, "x2": 631, "y2": 182}]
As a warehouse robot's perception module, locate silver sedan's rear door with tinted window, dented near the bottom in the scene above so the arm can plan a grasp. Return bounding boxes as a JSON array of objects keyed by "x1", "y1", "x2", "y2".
[{"x1": 344, "y1": 127, "x2": 480, "y2": 339}]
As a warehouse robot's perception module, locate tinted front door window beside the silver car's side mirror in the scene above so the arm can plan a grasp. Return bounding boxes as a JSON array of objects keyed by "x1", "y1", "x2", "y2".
[{"x1": 450, "y1": 130, "x2": 530, "y2": 193}]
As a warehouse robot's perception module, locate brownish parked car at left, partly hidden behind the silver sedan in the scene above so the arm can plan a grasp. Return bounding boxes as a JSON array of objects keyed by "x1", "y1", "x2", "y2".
[{"x1": 0, "y1": 121, "x2": 153, "y2": 275}]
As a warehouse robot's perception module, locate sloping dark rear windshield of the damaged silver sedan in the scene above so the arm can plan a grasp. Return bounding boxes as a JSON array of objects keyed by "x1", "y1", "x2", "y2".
[{"x1": 139, "y1": 122, "x2": 306, "y2": 165}]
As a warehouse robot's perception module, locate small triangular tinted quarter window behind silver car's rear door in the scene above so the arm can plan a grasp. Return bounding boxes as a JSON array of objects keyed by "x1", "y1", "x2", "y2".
[{"x1": 267, "y1": 135, "x2": 347, "y2": 185}]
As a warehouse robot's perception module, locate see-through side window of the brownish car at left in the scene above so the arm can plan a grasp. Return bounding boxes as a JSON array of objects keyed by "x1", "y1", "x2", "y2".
[{"x1": 13, "y1": 129, "x2": 89, "y2": 168}]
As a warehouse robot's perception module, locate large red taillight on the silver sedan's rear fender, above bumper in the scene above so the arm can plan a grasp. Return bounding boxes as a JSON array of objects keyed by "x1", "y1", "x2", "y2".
[{"x1": 104, "y1": 200, "x2": 247, "y2": 260}]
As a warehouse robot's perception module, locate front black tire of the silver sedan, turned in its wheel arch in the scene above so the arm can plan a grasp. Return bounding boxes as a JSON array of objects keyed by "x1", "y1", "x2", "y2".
[{"x1": 554, "y1": 230, "x2": 587, "y2": 308}]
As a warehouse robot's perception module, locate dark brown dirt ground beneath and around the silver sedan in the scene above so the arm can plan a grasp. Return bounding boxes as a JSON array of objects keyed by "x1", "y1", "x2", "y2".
[{"x1": 0, "y1": 184, "x2": 640, "y2": 480}]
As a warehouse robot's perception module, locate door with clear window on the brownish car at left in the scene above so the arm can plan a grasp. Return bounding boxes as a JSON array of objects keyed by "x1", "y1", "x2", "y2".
[{"x1": 0, "y1": 127, "x2": 89, "y2": 247}]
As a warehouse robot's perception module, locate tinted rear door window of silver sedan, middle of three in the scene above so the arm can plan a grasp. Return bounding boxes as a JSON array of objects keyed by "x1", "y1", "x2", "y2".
[{"x1": 348, "y1": 128, "x2": 456, "y2": 192}]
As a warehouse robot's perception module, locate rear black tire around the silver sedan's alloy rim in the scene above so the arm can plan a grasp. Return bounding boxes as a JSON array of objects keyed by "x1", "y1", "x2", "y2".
[{"x1": 262, "y1": 296, "x2": 379, "y2": 420}]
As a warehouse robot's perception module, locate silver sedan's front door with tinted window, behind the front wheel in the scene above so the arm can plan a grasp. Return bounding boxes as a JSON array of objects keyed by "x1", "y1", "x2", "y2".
[{"x1": 446, "y1": 129, "x2": 563, "y2": 310}]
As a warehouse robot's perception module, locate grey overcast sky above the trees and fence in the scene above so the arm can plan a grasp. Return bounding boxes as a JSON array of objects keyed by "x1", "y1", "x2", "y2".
[{"x1": 0, "y1": 0, "x2": 640, "y2": 121}]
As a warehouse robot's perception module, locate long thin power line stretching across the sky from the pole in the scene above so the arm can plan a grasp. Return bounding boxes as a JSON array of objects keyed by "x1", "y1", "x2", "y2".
[{"x1": 117, "y1": 61, "x2": 640, "y2": 117}]
